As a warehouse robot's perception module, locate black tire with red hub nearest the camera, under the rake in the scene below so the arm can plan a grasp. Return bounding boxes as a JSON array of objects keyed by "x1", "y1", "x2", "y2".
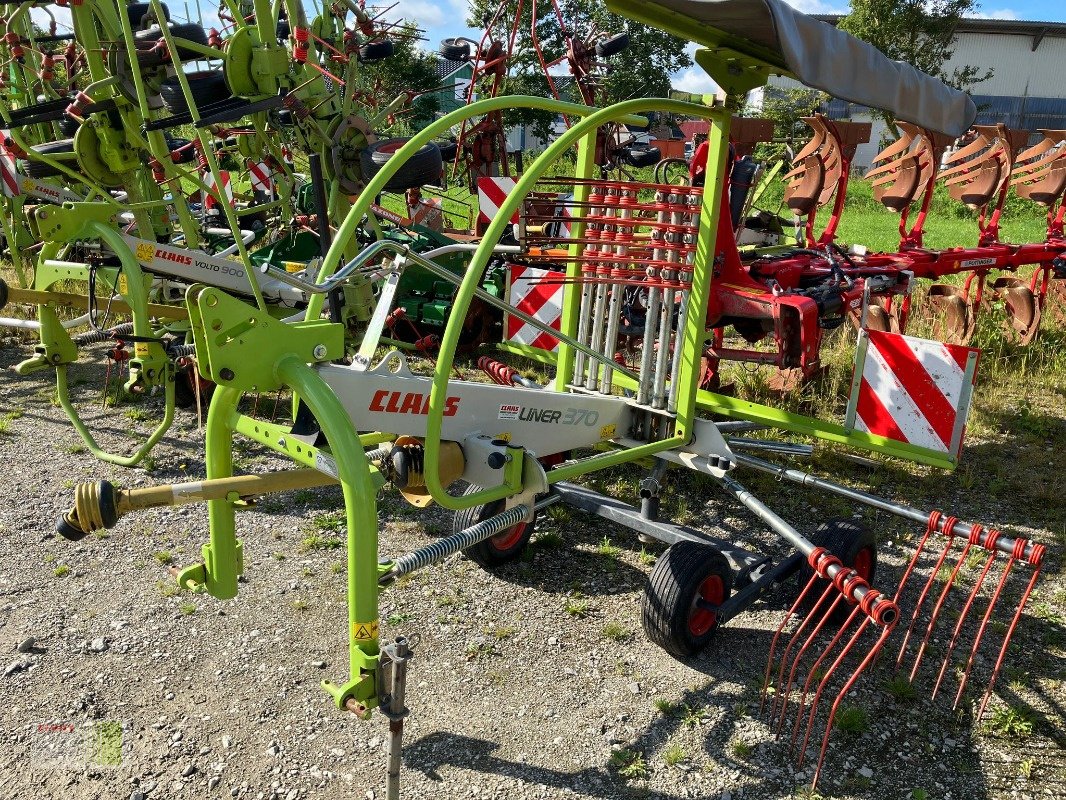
[{"x1": 641, "y1": 541, "x2": 733, "y2": 658}]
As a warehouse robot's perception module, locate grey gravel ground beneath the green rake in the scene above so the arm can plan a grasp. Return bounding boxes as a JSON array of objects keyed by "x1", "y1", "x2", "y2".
[{"x1": 0, "y1": 342, "x2": 1066, "y2": 800}]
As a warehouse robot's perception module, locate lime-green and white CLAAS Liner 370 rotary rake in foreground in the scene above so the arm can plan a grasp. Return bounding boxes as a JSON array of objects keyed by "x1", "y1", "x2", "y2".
[{"x1": 59, "y1": 0, "x2": 1044, "y2": 797}]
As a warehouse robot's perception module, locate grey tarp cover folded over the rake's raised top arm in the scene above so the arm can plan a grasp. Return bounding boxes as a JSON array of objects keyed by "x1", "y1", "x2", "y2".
[{"x1": 648, "y1": 0, "x2": 978, "y2": 137}]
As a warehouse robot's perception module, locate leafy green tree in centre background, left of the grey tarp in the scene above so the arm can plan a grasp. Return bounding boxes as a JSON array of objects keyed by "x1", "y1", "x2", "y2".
[{"x1": 467, "y1": 0, "x2": 692, "y2": 139}]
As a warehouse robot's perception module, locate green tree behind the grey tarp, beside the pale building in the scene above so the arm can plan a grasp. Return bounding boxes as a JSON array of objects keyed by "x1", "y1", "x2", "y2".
[{"x1": 837, "y1": 0, "x2": 992, "y2": 130}]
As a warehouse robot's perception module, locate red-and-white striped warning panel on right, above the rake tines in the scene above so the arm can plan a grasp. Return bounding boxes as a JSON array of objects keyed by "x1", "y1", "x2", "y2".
[{"x1": 844, "y1": 330, "x2": 981, "y2": 459}]
